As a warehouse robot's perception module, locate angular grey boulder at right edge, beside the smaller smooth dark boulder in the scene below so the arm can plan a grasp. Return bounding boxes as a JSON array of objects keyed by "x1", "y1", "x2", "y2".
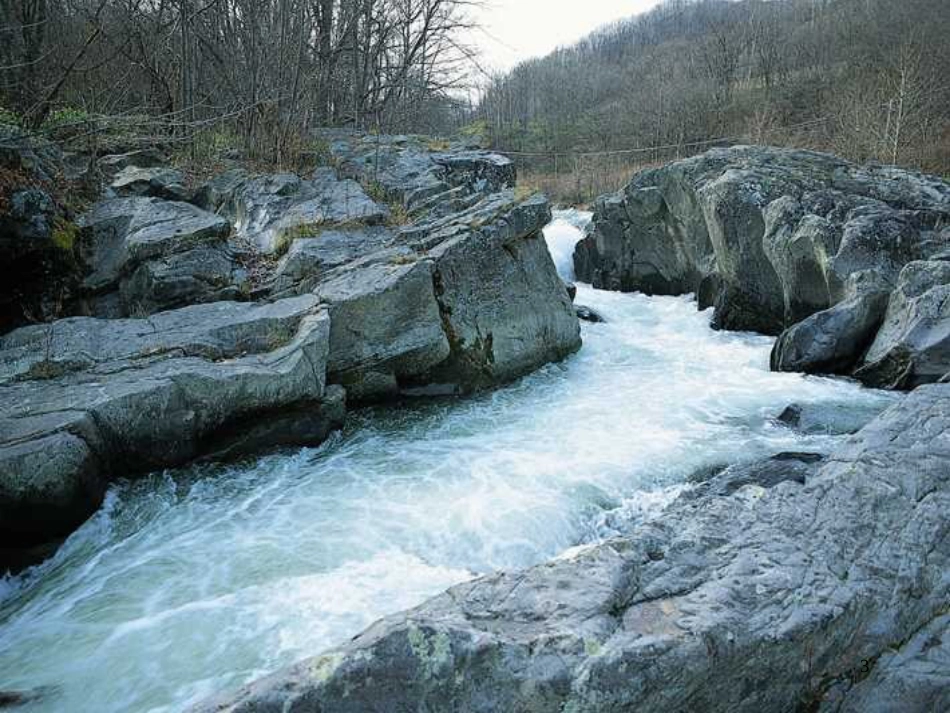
[{"x1": 855, "y1": 261, "x2": 950, "y2": 389}]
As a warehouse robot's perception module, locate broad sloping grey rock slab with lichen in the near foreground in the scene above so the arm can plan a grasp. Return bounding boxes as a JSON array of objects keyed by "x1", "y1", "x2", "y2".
[{"x1": 198, "y1": 385, "x2": 950, "y2": 713}]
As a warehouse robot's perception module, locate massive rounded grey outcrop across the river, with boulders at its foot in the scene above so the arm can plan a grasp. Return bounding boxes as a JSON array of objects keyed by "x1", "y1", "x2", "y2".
[{"x1": 575, "y1": 146, "x2": 950, "y2": 388}]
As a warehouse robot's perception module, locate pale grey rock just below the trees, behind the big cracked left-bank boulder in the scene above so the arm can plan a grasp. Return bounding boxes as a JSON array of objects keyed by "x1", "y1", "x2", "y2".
[{"x1": 196, "y1": 168, "x2": 390, "y2": 254}]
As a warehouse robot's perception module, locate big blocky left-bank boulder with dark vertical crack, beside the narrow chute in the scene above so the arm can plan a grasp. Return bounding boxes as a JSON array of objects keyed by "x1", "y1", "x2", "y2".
[{"x1": 273, "y1": 191, "x2": 580, "y2": 401}]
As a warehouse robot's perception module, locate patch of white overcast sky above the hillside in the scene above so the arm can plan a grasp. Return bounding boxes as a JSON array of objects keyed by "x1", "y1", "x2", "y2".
[{"x1": 472, "y1": 0, "x2": 660, "y2": 70}]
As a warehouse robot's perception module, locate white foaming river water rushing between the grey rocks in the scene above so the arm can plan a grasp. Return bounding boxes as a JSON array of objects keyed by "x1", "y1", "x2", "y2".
[{"x1": 0, "y1": 213, "x2": 889, "y2": 713}]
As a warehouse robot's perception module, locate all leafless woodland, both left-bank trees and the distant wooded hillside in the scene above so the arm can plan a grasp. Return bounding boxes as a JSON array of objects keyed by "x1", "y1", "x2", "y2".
[{"x1": 0, "y1": 0, "x2": 950, "y2": 196}]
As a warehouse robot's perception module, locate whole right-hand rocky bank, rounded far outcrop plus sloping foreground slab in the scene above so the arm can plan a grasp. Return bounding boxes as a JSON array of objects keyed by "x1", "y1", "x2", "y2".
[{"x1": 193, "y1": 148, "x2": 950, "y2": 713}]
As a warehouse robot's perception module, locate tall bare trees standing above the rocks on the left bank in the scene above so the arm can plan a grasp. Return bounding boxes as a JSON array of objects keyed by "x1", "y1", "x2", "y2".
[{"x1": 0, "y1": 0, "x2": 471, "y2": 163}]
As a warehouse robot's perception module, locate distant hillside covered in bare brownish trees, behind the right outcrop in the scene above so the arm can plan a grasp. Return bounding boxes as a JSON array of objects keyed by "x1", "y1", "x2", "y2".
[{"x1": 479, "y1": 0, "x2": 950, "y2": 197}]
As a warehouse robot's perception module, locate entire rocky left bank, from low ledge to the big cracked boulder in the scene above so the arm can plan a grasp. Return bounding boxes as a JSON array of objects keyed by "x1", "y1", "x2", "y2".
[{"x1": 0, "y1": 134, "x2": 580, "y2": 564}]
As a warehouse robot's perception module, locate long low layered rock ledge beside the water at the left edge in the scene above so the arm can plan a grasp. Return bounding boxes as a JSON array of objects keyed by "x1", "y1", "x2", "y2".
[{"x1": 0, "y1": 295, "x2": 344, "y2": 545}]
